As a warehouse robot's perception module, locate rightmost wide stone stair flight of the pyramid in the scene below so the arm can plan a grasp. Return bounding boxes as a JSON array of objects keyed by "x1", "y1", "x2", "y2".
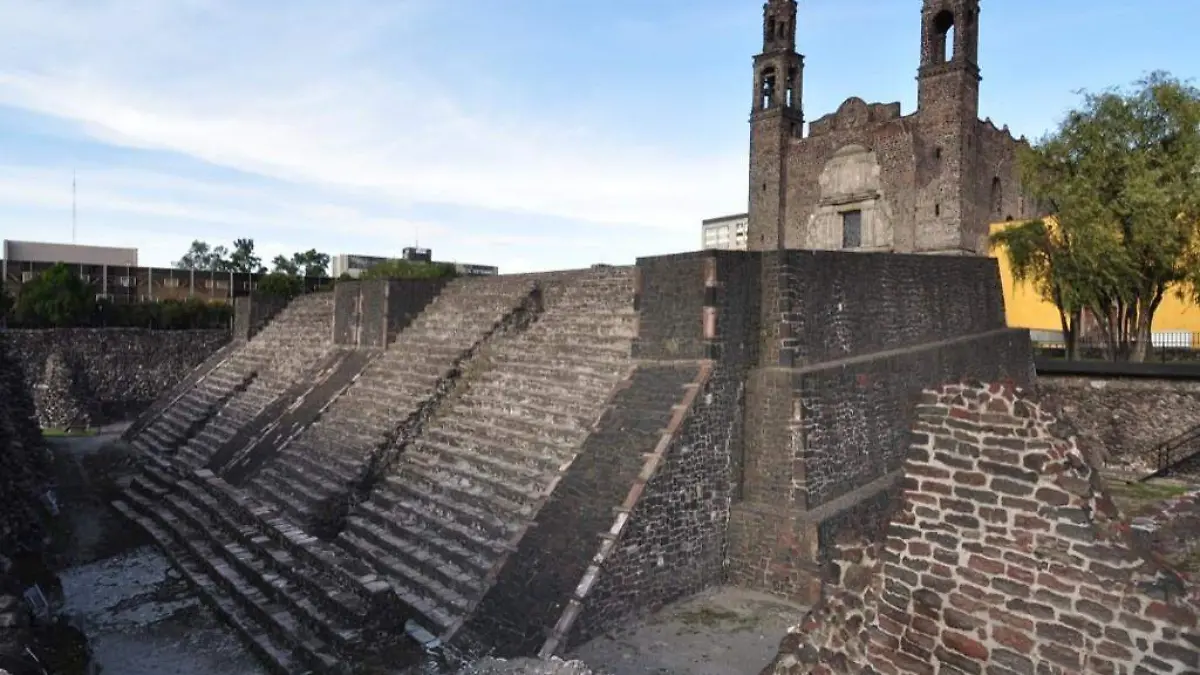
[{"x1": 336, "y1": 268, "x2": 636, "y2": 640}]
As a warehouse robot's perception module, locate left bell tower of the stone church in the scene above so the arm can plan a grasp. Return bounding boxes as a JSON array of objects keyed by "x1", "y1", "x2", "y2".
[{"x1": 746, "y1": 0, "x2": 804, "y2": 251}]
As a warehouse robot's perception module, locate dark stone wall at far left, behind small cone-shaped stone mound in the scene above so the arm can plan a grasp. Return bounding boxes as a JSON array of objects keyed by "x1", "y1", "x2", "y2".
[{"x1": 5, "y1": 328, "x2": 229, "y2": 425}]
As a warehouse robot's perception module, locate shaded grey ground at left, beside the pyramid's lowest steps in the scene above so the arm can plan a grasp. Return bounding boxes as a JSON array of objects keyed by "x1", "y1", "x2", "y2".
[{"x1": 50, "y1": 428, "x2": 265, "y2": 675}]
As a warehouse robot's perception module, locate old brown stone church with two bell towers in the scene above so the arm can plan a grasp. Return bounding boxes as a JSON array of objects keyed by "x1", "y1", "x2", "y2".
[{"x1": 749, "y1": 0, "x2": 1037, "y2": 253}]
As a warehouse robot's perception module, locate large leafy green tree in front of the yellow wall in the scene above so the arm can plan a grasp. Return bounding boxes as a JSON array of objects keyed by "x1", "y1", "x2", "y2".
[{"x1": 992, "y1": 72, "x2": 1200, "y2": 362}]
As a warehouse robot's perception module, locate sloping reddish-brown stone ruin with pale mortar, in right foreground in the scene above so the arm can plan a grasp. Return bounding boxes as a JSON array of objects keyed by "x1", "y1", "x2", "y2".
[{"x1": 764, "y1": 383, "x2": 1200, "y2": 675}]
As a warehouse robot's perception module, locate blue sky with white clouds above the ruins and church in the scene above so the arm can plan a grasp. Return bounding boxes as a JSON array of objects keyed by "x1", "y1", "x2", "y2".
[{"x1": 0, "y1": 0, "x2": 1200, "y2": 271}]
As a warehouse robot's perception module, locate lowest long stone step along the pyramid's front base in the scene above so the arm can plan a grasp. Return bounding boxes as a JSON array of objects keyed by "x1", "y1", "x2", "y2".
[{"x1": 113, "y1": 501, "x2": 308, "y2": 675}]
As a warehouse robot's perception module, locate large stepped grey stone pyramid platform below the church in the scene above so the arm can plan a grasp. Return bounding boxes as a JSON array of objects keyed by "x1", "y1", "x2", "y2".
[{"x1": 108, "y1": 246, "x2": 1032, "y2": 673}]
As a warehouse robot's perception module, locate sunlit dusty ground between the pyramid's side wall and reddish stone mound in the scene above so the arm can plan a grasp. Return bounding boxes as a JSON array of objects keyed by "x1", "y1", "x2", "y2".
[{"x1": 570, "y1": 587, "x2": 808, "y2": 675}]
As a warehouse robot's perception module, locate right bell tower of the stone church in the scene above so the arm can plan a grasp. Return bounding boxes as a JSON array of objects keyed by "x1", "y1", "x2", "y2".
[{"x1": 916, "y1": 0, "x2": 986, "y2": 255}]
